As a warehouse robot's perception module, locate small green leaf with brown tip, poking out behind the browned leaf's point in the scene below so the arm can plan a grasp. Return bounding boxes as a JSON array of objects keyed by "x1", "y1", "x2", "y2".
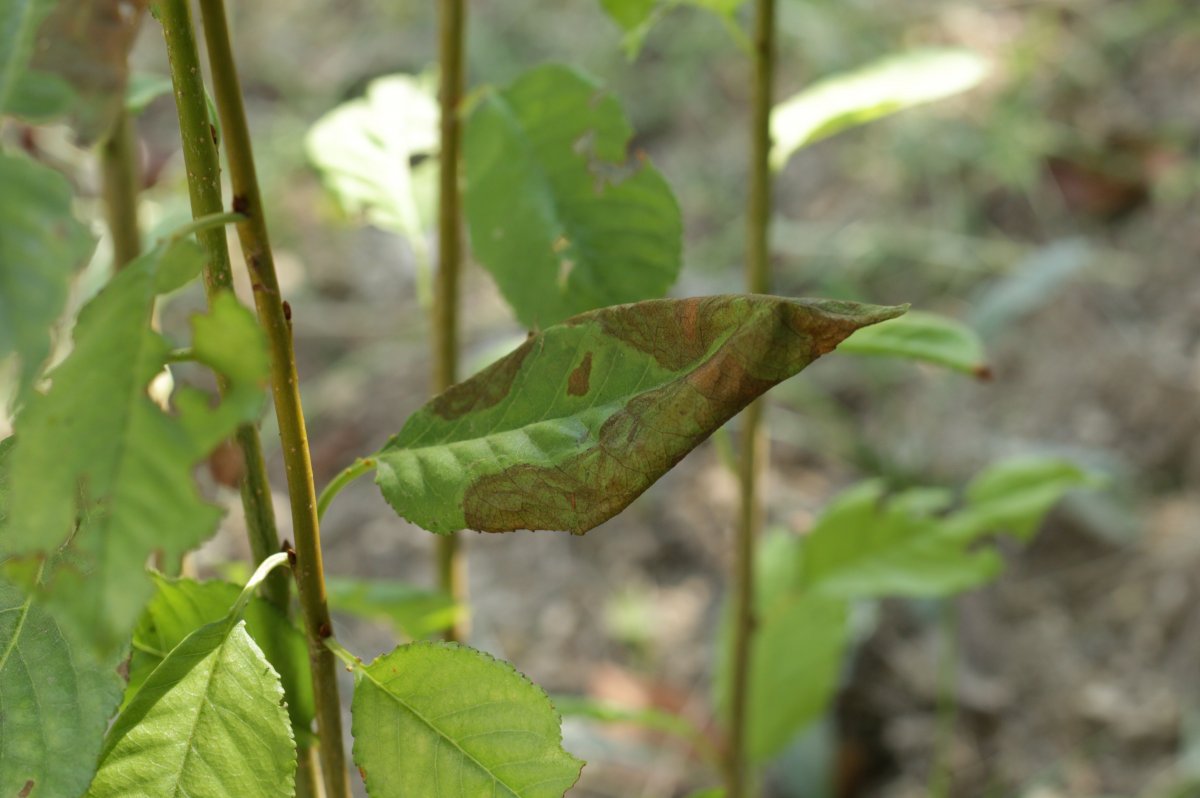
[{"x1": 841, "y1": 311, "x2": 991, "y2": 379}]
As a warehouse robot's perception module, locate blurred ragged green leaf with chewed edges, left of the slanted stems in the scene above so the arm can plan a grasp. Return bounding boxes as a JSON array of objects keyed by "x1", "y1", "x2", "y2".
[{"x1": 0, "y1": 249, "x2": 266, "y2": 650}]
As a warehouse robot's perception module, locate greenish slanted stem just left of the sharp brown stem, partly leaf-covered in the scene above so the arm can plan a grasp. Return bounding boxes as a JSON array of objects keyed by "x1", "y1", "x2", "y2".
[{"x1": 155, "y1": 0, "x2": 289, "y2": 612}]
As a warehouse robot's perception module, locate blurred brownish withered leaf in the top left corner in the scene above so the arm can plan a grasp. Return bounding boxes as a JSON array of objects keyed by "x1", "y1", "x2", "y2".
[{"x1": 6, "y1": 0, "x2": 146, "y2": 144}]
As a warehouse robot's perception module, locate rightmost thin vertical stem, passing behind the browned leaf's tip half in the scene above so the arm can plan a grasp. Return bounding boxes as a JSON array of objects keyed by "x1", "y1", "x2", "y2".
[{"x1": 726, "y1": 0, "x2": 775, "y2": 798}]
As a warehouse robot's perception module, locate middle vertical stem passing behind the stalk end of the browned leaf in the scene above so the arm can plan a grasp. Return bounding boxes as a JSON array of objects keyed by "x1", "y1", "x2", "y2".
[{"x1": 433, "y1": 0, "x2": 469, "y2": 640}]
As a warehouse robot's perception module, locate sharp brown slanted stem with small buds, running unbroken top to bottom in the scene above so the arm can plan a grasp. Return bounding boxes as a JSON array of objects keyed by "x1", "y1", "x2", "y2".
[{"x1": 200, "y1": 0, "x2": 350, "y2": 798}]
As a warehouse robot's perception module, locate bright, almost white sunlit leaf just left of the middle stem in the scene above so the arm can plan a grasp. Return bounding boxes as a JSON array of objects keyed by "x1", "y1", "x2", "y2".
[{"x1": 305, "y1": 74, "x2": 439, "y2": 302}]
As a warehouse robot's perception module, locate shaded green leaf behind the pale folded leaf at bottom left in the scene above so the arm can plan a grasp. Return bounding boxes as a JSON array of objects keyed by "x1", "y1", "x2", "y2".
[{"x1": 125, "y1": 574, "x2": 314, "y2": 739}]
